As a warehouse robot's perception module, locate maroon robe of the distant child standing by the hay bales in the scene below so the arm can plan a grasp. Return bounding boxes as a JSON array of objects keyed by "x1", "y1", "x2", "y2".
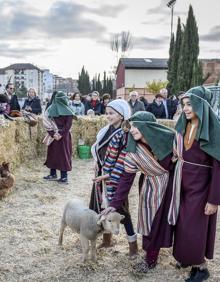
[{"x1": 44, "y1": 116, "x2": 73, "y2": 171}]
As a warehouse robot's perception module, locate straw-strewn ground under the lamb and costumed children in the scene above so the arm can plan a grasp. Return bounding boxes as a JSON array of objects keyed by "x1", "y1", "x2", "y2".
[{"x1": 0, "y1": 160, "x2": 220, "y2": 282}]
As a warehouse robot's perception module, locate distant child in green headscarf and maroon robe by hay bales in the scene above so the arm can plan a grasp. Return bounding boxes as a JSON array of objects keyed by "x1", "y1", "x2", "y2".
[{"x1": 44, "y1": 92, "x2": 74, "y2": 183}]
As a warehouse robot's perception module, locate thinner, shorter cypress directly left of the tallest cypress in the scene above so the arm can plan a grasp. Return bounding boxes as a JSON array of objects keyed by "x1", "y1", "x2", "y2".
[{"x1": 170, "y1": 18, "x2": 183, "y2": 95}]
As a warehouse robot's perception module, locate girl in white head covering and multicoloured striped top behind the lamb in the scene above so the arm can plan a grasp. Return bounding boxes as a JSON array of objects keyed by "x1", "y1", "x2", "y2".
[{"x1": 89, "y1": 99, "x2": 137, "y2": 256}]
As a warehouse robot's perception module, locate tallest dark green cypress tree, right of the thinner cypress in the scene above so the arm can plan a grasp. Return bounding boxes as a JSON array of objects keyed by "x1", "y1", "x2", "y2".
[{"x1": 177, "y1": 5, "x2": 199, "y2": 91}]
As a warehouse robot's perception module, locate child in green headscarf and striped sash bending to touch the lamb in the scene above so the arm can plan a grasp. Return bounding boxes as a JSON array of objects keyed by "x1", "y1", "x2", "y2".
[{"x1": 103, "y1": 112, "x2": 174, "y2": 273}]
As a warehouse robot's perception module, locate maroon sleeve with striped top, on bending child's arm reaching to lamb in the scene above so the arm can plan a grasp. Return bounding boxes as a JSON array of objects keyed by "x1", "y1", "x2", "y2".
[{"x1": 109, "y1": 153, "x2": 138, "y2": 209}]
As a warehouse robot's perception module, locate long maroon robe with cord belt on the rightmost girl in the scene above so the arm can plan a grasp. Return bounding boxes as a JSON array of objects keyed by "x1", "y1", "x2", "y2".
[{"x1": 173, "y1": 141, "x2": 220, "y2": 266}]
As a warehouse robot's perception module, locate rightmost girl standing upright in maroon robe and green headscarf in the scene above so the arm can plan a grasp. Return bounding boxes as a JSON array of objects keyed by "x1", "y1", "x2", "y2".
[{"x1": 169, "y1": 87, "x2": 220, "y2": 282}]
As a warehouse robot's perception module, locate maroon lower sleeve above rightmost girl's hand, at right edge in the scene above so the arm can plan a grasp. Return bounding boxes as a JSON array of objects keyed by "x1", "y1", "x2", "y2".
[{"x1": 207, "y1": 160, "x2": 220, "y2": 205}]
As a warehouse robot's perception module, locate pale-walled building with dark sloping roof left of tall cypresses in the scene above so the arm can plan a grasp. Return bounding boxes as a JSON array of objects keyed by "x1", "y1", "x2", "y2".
[{"x1": 116, "y1": 58, "x2": 168, "y2": 101}]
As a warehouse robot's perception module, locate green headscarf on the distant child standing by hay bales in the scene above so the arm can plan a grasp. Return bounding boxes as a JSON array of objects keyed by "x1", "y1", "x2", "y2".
[{"x1": 47, "y1": 91, "x2": 74, "y2": 118}]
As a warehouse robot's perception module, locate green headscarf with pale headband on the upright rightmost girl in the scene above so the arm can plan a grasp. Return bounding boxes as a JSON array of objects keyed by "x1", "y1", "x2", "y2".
[{"x1": 176, "y1": 87, "x2": 220, "y2": 161}]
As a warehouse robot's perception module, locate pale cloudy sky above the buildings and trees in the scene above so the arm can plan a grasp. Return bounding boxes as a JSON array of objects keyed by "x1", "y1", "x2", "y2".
[{"x1": 0, "y1": 0, "x2": 220, "y2": 78}]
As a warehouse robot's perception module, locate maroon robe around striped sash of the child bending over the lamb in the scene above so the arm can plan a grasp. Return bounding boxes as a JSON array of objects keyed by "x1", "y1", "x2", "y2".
[{"x1": 110, "y1": 153, "x2": 173, "y2": 251}]
